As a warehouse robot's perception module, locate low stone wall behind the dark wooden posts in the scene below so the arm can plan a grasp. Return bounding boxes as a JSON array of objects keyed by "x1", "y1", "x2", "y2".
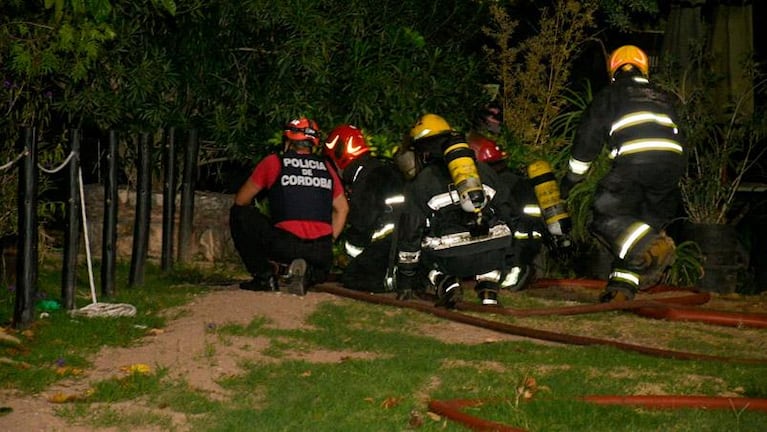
[{"x1": 82, "y1": 185, "x2": 239, "y2": 262}]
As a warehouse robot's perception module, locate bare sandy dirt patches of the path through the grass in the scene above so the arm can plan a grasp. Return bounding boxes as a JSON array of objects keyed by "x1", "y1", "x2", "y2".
[{"x1": 0, "y1": 285, "x2": 540, "y2": 432}]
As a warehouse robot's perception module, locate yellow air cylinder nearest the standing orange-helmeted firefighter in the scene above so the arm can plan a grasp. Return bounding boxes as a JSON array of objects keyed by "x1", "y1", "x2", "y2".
[{"x1": 527, "y1": 160, "x2": 572, "y2": 236}]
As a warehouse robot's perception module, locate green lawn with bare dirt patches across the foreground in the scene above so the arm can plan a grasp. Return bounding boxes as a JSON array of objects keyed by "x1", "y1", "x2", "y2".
[{"x1": 0, "y1": 258, "x2": 767, "y2": 432}]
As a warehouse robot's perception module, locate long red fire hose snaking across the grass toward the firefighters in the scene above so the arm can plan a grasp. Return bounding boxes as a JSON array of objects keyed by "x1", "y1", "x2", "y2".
[{"x1": 315, "y1": 279, "x2": 767, "y2": 432}]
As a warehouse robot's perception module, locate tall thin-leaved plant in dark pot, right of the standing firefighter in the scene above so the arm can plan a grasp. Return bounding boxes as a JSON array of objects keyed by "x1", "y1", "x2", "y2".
[{"x1": 664, "y1": 67, "x2": 767, "y2": 293}]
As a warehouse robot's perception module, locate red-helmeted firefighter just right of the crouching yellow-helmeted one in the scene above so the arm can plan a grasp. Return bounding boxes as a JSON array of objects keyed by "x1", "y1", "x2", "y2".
[{"x1": 468, "y1": 133, "x2": 548, "y2": 291}]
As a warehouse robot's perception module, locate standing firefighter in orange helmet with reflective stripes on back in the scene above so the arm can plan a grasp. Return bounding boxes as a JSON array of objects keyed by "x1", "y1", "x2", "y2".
[{"x1": 561, "y1": 45, "x2": 686, "y2": 302}]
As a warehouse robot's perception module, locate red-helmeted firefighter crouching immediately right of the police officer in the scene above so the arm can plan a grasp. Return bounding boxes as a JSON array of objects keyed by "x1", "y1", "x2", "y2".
[{"x1": 323, "y1": 124, "x2": 405, "y2": 292}]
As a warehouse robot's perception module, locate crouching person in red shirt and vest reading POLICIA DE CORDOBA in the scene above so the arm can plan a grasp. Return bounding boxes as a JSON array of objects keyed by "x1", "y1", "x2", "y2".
[{"x1": 229, "y1": 117, "x2": 349, "y2": 295}]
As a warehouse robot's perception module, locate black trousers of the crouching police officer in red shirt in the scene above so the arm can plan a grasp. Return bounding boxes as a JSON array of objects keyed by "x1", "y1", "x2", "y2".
[{"x1": 229, "y1": 205, "x2": 333, "y2": 283}]
